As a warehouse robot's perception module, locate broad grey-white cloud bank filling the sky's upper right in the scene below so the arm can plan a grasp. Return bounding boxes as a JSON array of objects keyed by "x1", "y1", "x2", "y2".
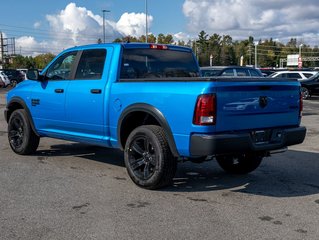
[{"x1": 183, "y1": 0, "x2": 319, "y2": 44}]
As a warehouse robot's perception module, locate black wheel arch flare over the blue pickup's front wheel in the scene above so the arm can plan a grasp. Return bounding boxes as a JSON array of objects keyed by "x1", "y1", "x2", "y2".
[{"x1": 5, "y1": 97, "x2": 40, "y2": 136}]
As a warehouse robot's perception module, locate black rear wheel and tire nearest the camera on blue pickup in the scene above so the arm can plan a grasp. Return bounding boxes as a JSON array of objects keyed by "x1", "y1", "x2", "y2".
[{"x1": 124, "y1": 125, "x2": 177, "y2": 189}]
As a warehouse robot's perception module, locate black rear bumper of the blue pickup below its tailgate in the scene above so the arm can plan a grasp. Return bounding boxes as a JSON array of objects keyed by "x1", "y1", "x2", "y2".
[{"x1": 190, "y1": 127, "x2": 306, "y2": 156}]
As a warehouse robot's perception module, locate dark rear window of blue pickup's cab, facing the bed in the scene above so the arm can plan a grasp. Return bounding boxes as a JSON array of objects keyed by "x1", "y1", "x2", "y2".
[{"x1": 120, "y1": 49, "x2": 199, "y2": 79}]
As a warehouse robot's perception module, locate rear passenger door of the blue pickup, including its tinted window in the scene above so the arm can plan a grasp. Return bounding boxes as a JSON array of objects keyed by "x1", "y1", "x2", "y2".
[{"x1": 65, "y1": 48, "x2": 112, "y2": 143}]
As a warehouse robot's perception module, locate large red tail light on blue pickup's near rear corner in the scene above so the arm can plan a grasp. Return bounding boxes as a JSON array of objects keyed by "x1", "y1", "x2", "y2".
[{"x1": 193, "y1": 94, "x2": 216, "y2": 125}]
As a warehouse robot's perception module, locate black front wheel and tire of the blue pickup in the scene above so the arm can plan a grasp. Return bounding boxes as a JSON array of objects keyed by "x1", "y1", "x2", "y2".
[{"x1": 8, "y1": 109, "x2": 40, "y2": 155}]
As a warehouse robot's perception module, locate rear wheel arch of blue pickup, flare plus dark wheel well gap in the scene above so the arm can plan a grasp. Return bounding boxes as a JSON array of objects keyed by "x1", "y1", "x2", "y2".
[{"x1": 117, "y1": 103, "x2": 180, "y2": 157}]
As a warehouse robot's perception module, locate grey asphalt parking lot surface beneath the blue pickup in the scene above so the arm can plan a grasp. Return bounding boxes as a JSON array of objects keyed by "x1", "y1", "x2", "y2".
[{"x1": 0, "y1": 86, "x2": 319, "y2": 240}]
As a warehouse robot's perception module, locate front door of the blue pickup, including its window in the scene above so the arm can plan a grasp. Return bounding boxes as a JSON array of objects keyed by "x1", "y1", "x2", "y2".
[{"x1": 30, "y1": 51, "x2": 78, "y2": 133}]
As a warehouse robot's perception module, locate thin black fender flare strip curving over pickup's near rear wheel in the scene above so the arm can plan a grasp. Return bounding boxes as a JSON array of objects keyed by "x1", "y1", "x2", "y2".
[{"x1": 117, "y1": 103, "x2": 180, "y2": 157}]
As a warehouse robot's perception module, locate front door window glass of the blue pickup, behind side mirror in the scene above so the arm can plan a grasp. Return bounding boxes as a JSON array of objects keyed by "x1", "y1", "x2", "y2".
[{"x1": 46, "y1": 51, "x2": 77, "y2": 80}]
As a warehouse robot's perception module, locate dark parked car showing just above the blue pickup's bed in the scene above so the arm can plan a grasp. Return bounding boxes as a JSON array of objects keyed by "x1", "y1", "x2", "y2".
[{"x1": 200, "y1": 66, "x2": 263, "y2": 77}]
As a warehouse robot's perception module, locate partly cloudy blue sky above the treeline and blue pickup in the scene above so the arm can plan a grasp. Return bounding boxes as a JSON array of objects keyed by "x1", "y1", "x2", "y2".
[{"x1": 0, "y1": 0, "x2": 319, "y2": 55}]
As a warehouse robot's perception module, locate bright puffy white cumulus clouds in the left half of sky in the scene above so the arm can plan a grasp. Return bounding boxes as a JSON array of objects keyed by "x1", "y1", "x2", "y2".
[{"x1": 16, "y1": 3, "x2": 153, "y2": 55}]
